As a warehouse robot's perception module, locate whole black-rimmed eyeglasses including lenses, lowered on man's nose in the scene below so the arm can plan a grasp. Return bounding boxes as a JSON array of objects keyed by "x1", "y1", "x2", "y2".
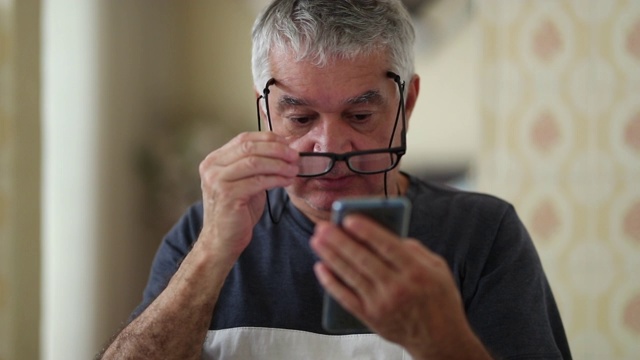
[{"x1": 256, "y1": 71, "x2": 407, "y2": 177}]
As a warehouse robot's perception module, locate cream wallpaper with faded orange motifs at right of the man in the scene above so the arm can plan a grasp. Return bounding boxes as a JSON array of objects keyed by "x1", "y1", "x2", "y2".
[{"x1": 476, "y1": 0, "x2": 640, "y2": 359}]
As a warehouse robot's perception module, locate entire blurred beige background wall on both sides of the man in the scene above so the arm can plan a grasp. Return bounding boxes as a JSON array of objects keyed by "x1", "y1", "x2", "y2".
[{"x1": 0, "y1": 0, "x2": 640, "y2": 360}]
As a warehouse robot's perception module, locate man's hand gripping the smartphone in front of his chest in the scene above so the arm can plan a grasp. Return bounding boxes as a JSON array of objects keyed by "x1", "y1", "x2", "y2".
[{"x1": 311, "y1": 197, "x2": 479, "y2": 358}]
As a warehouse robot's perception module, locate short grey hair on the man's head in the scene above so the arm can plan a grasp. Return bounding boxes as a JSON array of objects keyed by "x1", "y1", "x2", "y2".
[{"x1": 251, "y1": 0, "x2": 415, "y2": 91}]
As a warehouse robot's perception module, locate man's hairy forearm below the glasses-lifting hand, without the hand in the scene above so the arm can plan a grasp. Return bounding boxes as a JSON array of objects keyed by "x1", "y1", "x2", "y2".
[{"x1": 103, "y1": 241, "x2": 233, "y2": 359}]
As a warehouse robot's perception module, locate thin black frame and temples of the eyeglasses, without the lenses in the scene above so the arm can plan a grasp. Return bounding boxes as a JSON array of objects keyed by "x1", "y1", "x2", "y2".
[{"x1": 256, "y1": 71, "x2": 407, "y2": 178}]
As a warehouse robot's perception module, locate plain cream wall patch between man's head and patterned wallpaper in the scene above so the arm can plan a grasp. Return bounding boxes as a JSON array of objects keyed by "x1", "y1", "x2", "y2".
[{"x1": 402, "y1": 13, "x2": 481, "y2": 174}]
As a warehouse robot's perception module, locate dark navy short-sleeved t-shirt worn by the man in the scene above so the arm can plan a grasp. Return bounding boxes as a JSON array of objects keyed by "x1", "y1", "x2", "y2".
[{"x1": 132, "y1": 177, "x2": 571, "y2": 359}]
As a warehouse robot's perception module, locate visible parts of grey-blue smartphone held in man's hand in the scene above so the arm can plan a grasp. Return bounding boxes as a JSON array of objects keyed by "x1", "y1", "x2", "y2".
[{"x1": 322, "y1": 197, "x2": 411, "y2": 334}]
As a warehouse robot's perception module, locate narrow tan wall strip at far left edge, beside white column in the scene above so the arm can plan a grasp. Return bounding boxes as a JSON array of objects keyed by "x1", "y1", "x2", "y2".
[{"x1": 0, "y1": 0, "x2": 41, "y2": 359}]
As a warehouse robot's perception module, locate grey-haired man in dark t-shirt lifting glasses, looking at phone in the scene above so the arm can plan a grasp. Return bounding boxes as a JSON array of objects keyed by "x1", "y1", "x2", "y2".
[{"x1": 99, "y1": 0, "x2": 571, "y2": 359}]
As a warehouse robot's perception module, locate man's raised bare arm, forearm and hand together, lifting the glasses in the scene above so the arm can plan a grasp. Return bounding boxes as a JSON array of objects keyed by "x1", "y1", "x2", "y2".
[{"x1": 98, "y1": 132, "x2": 298, "y2": 359}]
